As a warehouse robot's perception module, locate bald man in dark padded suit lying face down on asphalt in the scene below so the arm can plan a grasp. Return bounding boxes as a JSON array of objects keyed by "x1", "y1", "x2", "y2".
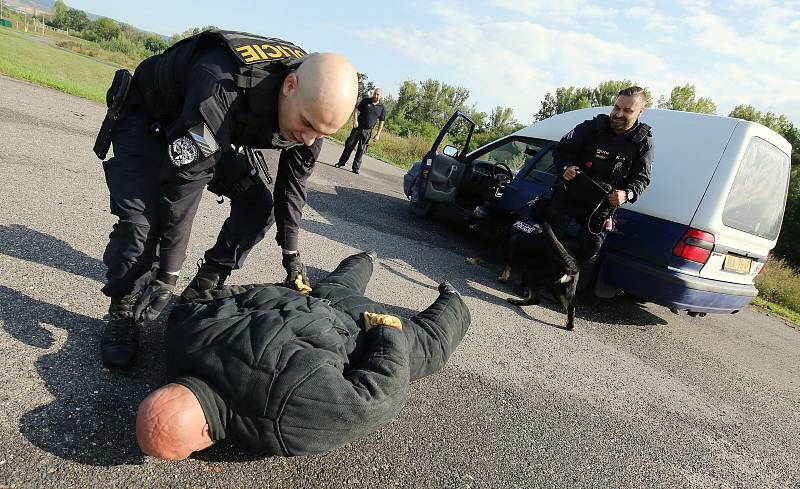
[{"x1": 136, "y1": 252, "x2": 470, "y2": 460}]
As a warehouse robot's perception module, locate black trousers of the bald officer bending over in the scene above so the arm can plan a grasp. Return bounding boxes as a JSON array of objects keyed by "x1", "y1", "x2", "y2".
[{"x1": 102, "y1": 111, "x2": 274, "y2": 297}]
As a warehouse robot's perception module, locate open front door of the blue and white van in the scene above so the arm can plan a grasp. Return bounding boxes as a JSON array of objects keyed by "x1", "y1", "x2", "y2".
[{"x1": 411, "y1": 111, "x2": 475, "y2": 213}]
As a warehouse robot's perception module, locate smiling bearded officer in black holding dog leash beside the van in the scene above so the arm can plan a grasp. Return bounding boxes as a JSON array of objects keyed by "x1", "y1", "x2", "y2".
[{"x1": 546, "y1": 87, "x2": 655, "y2": 263}]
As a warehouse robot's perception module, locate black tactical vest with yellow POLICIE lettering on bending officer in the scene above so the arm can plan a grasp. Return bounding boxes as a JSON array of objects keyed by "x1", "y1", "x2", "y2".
[{"x1": 137, "y1": 29, "x2": 306, "y2": 132}]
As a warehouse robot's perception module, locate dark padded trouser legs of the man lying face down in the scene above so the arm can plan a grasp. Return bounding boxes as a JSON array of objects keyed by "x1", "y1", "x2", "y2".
[{"x1": 311, "y1": 253, "x2": 471, "y2": 380}]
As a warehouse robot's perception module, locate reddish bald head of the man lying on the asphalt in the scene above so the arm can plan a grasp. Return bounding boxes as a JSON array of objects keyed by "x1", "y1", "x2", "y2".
[{"x1": 136, "y1": 384, "x2": 213, "y2": 460}]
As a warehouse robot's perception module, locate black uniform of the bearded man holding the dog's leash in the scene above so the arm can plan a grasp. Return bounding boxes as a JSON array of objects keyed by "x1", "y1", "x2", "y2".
[{"x1": 547, "y1": 114, "x2": 655, "y2": 261}]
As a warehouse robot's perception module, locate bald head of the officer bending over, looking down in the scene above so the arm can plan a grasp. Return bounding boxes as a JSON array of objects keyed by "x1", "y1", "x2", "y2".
[{"x1": 278, "y1": 53, "x2": 358, "y2": 146}]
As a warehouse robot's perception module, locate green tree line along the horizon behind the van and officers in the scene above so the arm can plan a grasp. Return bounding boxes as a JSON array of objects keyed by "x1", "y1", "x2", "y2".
[{"x1": 39, "y1": 0, "x2": 800, "y2": 265}]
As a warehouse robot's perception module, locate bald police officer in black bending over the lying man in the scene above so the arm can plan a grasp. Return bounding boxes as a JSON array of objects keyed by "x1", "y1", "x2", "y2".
[{"x1": 94, "y1": 30, "x2": 358, "y2": 368}]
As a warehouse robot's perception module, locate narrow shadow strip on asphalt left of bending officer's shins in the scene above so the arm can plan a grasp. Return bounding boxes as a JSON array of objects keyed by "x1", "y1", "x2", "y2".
[{"x1": 0, "y1": 224, "x2": 106, "y2": 282}]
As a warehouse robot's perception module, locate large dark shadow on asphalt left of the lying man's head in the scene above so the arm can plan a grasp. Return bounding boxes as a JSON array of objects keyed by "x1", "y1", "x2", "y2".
[{"x1": 0, "y1": 286, "x2": 158, "y2": 466}]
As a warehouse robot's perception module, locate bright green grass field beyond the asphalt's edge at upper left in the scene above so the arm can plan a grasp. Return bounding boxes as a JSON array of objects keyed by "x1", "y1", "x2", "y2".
[{"x1": 0, "y1": 27, "x2": 117, "y2": 102}]
